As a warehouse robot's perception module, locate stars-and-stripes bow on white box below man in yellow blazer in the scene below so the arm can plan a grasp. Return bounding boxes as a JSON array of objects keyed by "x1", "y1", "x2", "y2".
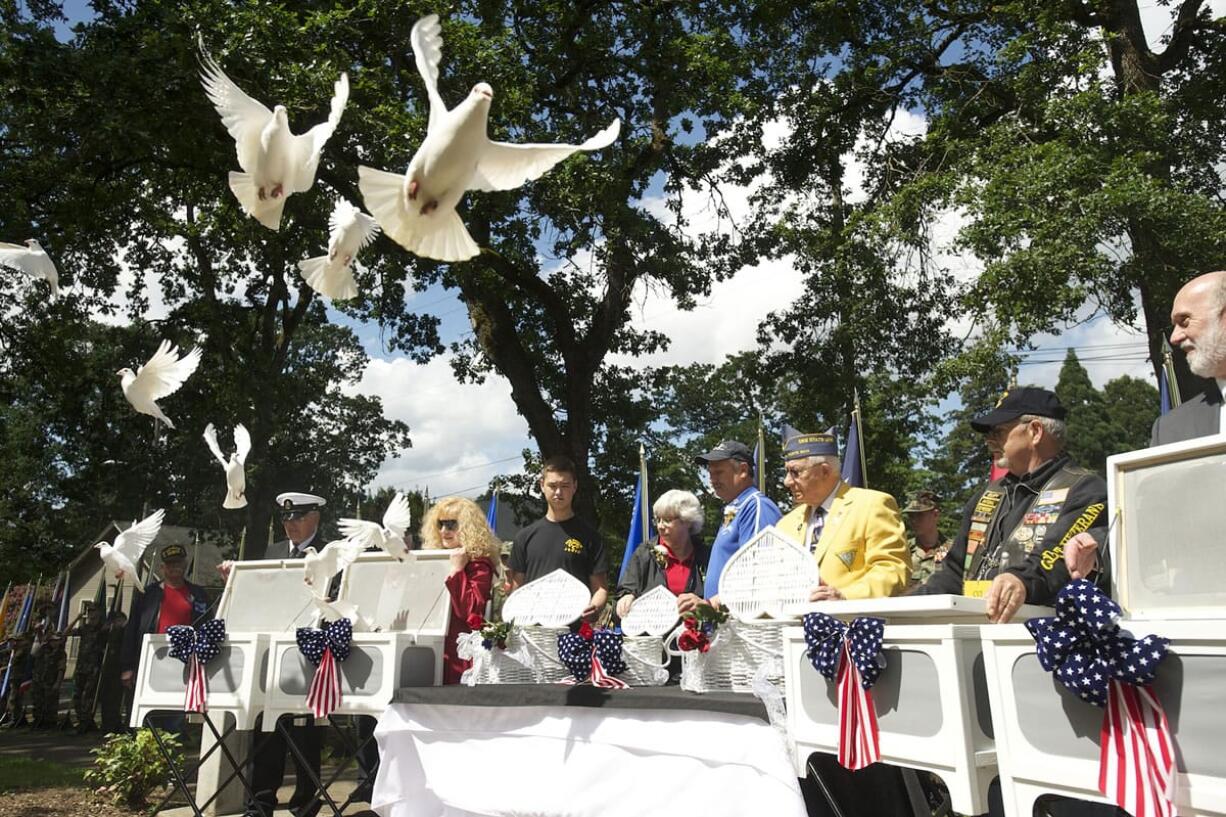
[{"x1": 804, "y1": 613, "x2": 885, "y2": 772}]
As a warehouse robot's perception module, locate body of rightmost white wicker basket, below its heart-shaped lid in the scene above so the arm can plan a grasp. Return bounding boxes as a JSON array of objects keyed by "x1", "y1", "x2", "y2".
[{"x1": 667, "y1": 619, "x2": 796, "y2": 692}]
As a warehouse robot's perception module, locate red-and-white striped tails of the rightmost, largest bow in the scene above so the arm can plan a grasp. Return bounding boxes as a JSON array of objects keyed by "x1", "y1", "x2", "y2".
[{"x1": 1098, "y1": 681, "x2": 1176, "y2": 817}]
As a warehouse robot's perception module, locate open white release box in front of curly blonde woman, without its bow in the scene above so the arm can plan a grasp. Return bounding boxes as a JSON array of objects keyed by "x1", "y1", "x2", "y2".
[{"x1": 264, "y1": 551, "x2": 451, "y2": 730}]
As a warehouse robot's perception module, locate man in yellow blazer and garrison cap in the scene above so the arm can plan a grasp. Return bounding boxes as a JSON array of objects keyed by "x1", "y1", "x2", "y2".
[{"x1": 777, "y1": 428, "x2": 911, "y2": 601}]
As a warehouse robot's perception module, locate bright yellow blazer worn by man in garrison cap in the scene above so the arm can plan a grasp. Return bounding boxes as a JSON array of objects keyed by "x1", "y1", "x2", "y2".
[{"x1": 776, "y1": 482, "x2": 911, "y2": 599}]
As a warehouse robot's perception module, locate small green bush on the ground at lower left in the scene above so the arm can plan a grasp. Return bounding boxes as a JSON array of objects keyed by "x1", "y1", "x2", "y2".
[{"x1": 85, "y1": 729, "x2": 181, "y2": 810}]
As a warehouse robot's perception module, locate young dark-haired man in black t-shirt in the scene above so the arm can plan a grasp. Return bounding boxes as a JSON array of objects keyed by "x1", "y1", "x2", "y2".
[{"x1": 509, "y1": 456, "x2": 608, "y2": 618}]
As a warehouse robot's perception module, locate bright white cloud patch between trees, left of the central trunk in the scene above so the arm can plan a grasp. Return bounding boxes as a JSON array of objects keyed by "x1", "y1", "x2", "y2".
[{"x1": 349, "y1": 356, "x2": 530, "y2": 497}]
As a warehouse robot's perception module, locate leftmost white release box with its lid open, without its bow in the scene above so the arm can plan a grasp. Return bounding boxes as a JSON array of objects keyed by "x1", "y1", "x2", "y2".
[{"x1": 131, "y1": 559, "x2": 316, "y2": 729}]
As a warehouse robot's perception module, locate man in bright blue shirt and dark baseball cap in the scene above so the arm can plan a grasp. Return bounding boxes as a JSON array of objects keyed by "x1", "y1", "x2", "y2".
[{"x1": 696, "y1": 439, "x2": 782, "y2": 603}]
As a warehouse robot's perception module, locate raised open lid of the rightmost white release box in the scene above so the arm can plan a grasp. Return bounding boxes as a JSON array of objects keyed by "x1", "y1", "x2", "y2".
[{"x1": 1107, "y1": 434, "x2": 1226, "y2": 619}]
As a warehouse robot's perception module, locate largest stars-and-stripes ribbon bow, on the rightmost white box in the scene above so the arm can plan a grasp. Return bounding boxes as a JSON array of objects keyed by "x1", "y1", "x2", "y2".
[{"x1": 1026, "y1": 579, "x2": 1176, "y2": 817}]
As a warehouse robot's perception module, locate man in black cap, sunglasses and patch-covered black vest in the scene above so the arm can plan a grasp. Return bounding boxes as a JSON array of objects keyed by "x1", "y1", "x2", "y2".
[{"x1": 912, "y1": 386, "x2": 1107, "y2": 623}]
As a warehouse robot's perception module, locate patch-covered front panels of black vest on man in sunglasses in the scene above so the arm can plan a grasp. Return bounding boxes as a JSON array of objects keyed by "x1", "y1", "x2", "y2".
[{"x1": 962, "y1": 465, "x2": 1090, "y2": 597}]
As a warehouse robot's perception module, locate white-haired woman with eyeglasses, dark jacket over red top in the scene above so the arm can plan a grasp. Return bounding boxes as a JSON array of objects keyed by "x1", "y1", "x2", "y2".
[{"x1": 617, "y1": 489, "x2": 711, "y2": 618}]
